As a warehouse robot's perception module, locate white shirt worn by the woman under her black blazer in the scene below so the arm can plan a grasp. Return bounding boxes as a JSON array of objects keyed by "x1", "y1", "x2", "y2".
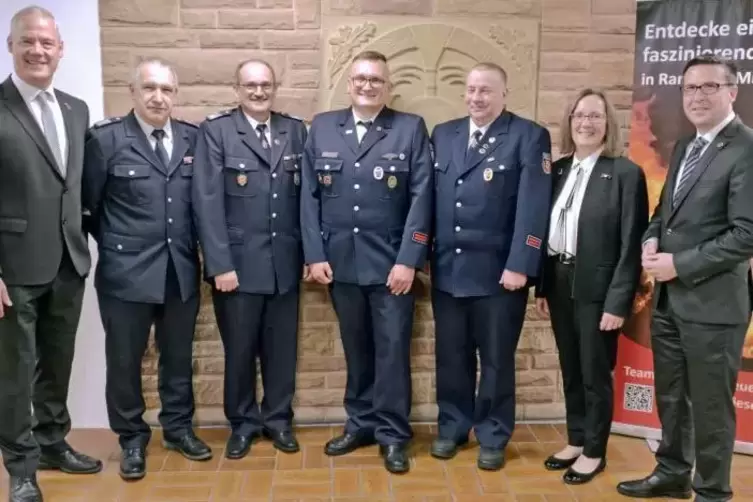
[{"x1": 548, "y1": 149, "x2": 601, "y2": 256}]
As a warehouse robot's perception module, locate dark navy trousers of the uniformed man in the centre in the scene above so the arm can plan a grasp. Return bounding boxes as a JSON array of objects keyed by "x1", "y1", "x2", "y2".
[{"x1": 330, "y1": 282, "x2": 415, "y2": 445}]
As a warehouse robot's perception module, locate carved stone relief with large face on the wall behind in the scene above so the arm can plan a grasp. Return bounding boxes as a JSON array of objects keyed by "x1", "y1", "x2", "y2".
[{"x1": 319, "y1": 17, "x2": 539, "y2": 130}]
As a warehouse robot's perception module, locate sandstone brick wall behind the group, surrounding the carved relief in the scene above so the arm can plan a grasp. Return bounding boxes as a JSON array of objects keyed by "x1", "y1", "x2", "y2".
[{"x1": 95, "y1": 0, "x2": 635, "y2": 423}]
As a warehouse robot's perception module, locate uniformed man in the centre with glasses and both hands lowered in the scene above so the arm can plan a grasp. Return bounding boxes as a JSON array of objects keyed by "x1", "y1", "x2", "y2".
[{"x1": 301, "y1": 52, "x2": 432, "y2": 472}]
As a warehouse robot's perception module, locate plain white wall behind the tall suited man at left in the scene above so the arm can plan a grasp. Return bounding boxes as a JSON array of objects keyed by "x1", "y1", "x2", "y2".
[{"x1": 0, "y1": 0, "x2": 108, "y2": 427}]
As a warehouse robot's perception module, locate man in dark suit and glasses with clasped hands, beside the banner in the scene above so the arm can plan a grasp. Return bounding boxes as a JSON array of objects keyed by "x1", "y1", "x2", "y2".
[{"x1": 617, "y1": 57, "x2": 753, "y2": 501}]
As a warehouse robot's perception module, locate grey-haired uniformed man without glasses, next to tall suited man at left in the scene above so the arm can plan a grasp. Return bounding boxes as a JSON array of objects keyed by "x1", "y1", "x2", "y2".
[{"x1": 82, "y1": 59, "x2": 212, "y2": 479}]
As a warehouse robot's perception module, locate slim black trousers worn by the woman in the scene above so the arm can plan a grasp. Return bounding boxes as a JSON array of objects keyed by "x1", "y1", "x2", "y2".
[{"x1": 547, "y1": 258, "x2": 620, "y2": 458}]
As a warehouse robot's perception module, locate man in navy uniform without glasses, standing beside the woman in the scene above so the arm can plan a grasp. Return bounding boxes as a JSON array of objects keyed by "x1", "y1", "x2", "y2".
[{"x1": 431, "y1": 63, "x2": 551, "y2": 470}]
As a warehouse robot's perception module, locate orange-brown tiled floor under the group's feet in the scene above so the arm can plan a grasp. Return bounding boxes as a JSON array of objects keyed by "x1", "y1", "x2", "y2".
[{"x1": 0, "y1": 425, "x2": 753, "y2": 502}]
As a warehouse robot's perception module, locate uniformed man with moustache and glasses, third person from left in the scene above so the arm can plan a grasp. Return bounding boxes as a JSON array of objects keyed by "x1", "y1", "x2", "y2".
[{"x1": 194, "y1": 60, "x2": 307, "y2": 458}]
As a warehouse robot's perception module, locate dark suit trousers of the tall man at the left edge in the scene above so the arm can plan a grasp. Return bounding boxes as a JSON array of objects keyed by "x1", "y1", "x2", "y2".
[{"x1": 0, "y1": 251, "x2": 85, "y2": 476}]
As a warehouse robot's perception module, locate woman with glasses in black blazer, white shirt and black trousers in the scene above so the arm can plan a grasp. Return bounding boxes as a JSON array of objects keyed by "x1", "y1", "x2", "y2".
[{"x1": 536, "y1": 89, "x2": 648, "y2": 484}]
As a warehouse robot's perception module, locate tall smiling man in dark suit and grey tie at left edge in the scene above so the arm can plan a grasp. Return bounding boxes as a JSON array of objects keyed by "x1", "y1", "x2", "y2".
[{"x1": 0, "y1": 7, "x2": 102, "y2": 502}]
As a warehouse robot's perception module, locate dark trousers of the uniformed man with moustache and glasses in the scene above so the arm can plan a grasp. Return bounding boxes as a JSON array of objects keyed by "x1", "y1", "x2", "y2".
[{"x1": 213, "y1": 289, "x2": 299, "y2": 436}]
